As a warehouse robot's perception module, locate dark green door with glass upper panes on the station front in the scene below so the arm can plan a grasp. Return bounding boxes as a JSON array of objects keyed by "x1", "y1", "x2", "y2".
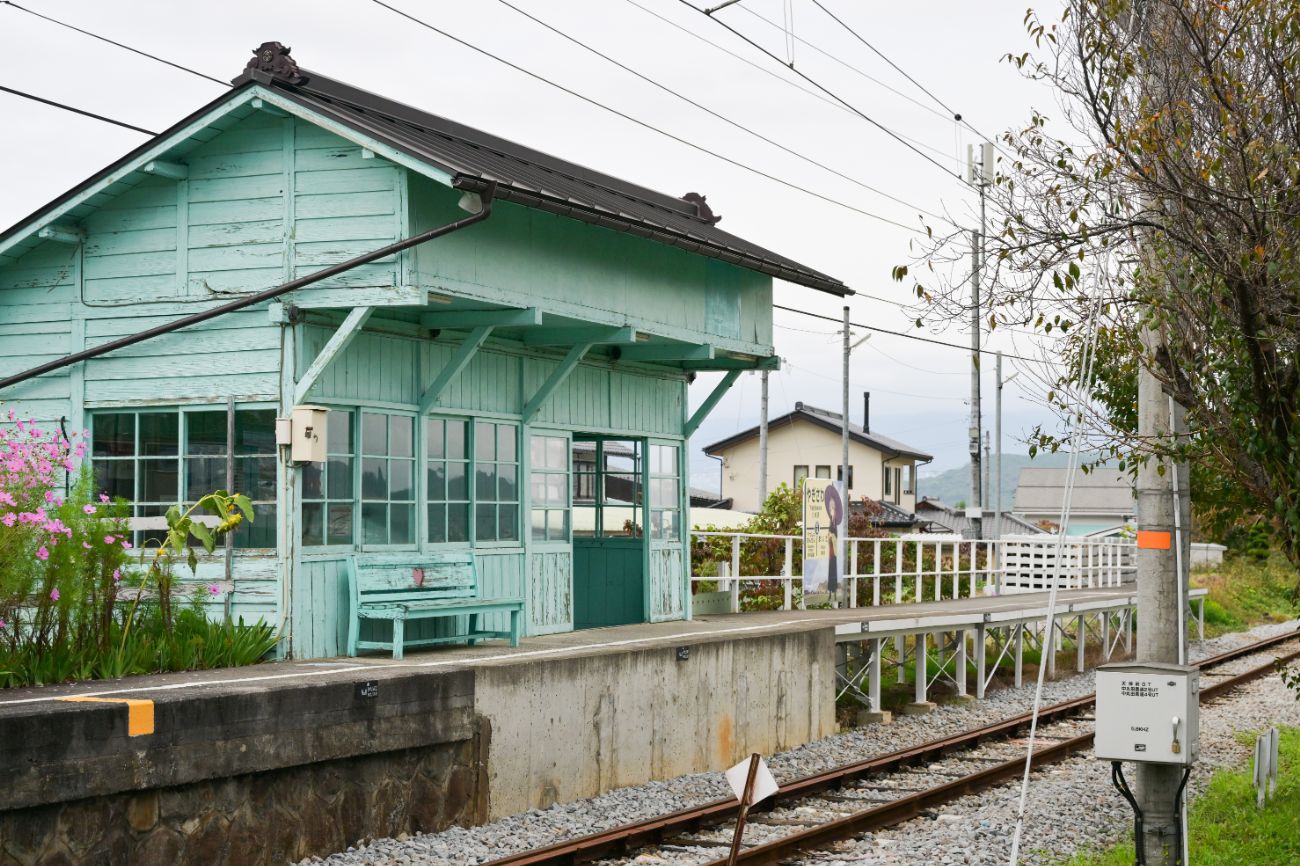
[{"x1": 573, "y1": 436, "x2": 647, "y2": 628}]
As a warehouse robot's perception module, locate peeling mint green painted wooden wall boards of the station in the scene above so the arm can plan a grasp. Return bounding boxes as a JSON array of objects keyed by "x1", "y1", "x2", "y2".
[{"x1": 0, "y1": 92, "x2": 771, "y2": 657}]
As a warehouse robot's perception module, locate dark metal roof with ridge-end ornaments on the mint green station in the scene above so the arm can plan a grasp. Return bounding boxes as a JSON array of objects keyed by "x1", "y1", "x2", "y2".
[{"x1": 0, "y1": 43, "x2": 853, "y2": 295}]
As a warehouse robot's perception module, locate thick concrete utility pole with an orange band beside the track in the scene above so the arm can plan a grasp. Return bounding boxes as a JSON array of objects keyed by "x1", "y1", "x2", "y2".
[{"x1": 1135, "y1": 328, "x2": 1191, "y2": 866}]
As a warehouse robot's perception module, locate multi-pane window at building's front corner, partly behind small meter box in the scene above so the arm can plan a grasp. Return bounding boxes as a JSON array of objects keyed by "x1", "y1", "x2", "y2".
[{"x1": 303, "y1": 410, "x2": 356, "y2": 545}]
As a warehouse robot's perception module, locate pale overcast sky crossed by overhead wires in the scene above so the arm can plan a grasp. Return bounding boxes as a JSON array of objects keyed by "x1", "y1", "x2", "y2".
[{"x1": 0, "y1": 0, "x2": 1076, "y2": 486}]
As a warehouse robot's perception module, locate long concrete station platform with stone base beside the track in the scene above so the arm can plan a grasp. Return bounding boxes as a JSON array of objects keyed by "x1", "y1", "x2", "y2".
[{"x1": 0, "y1": 586, "x2": 1195, "y2": 862}]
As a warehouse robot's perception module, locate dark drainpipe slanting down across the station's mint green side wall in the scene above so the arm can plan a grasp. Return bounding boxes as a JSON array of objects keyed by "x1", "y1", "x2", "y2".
[{"x1": 0, "y1": 182, "x2": 497, "y2": 390}]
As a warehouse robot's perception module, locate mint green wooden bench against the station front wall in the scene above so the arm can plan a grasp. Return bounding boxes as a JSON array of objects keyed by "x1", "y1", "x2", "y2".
[{"x1": 347, "y1": 550, "x2": 524, "y2": 658}]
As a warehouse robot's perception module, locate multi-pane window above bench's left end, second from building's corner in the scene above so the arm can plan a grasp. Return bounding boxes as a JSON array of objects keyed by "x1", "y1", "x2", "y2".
[{"x1": 361, "y1": 411, "x2": 415, "y2": 545}]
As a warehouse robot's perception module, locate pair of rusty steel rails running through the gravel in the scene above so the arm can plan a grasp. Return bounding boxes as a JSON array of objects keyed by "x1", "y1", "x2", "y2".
[{"x1": 485, "y1": 632, "x2": 1300, "y2": 866}]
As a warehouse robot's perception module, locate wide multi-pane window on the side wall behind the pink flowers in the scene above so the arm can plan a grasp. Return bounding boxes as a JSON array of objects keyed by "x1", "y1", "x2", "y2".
[{"x1": 91, "y1": 406, "x2": 276, "y2": 549}]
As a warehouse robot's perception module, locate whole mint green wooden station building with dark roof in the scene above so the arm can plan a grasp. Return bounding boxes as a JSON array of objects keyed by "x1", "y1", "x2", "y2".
[{"x1": 0, "y1": 43, "x2": 849, "y2": 658}]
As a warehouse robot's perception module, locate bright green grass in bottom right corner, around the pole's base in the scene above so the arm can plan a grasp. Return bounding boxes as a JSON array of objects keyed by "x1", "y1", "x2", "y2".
[{"x1": 1066, "y1": 728, "x2": 1300, "y2": 866}]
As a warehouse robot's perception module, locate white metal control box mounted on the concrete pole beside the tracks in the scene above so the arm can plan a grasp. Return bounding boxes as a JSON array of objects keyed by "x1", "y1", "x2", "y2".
[{"x1": 1093, "y1": 663, "x2": 1201, "y2": 765}]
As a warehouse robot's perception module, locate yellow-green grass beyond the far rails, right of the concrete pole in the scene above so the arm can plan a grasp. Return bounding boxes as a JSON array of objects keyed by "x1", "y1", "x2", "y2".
[{"x1": 1192, "y1": 553, "x2": 1300, "y2": 637}]
